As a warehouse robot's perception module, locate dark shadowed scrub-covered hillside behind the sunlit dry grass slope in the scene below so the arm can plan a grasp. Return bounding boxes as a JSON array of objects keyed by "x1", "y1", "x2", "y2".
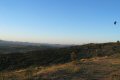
[{"x1": 0, "y1": 43, "x2": 120, "y2": 70}]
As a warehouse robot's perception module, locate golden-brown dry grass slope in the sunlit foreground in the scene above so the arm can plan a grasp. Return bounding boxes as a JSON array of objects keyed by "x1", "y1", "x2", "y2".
[{"x1": 0, "y1": 54, "x2": 120, "y2": 80}]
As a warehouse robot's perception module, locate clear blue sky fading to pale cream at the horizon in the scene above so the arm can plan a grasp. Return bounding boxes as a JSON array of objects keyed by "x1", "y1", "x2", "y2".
[{"x1": 0, "y1": 0, "x2": 120, "y2": 44}]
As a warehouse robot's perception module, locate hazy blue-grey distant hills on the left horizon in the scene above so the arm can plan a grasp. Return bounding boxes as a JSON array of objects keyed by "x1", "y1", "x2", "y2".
[{"x1": 0, "y1": 40, "x2": 66, "y2": 54}]
